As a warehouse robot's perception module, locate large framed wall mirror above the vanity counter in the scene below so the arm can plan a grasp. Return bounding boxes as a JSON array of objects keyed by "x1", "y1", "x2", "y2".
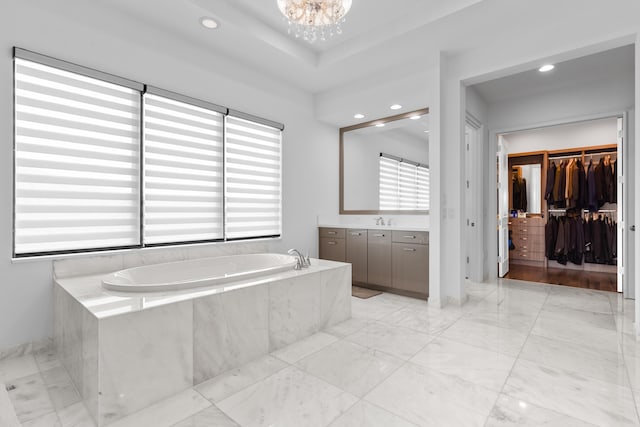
[{"x1": 340, "y1": 108, "x2": 429, "y2": 215}]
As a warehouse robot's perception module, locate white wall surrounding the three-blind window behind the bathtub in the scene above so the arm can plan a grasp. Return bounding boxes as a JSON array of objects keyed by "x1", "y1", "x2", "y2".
[{"x1": 0, "y1": 0, "x2": 338, "y2": 352}]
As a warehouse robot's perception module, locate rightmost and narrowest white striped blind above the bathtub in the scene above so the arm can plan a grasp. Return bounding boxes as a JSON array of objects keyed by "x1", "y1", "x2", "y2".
[{"x1": 225, "y1": 116, "x2": 282, "y2": 239}]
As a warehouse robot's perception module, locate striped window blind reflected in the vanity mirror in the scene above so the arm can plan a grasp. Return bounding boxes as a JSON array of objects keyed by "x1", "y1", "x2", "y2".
[{"x1": 379, "y1": 154, "x2": 429, "y2": 210}]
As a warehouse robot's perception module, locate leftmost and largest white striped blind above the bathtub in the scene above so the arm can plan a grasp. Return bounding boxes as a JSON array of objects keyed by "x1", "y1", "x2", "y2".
[{"x1": 14, "y1": 58, "x2": 140, "y2": 255}]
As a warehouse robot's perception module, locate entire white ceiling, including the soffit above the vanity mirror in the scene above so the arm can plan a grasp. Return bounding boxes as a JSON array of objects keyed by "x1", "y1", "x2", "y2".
[{"x1": 37, "y1": 0, "x2": 640, "y2": 126}]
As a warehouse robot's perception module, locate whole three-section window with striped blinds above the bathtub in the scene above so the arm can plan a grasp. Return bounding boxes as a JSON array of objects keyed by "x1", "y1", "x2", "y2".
[{"x1": 14, "y1": 49, "x2": 283, "y2": 257}]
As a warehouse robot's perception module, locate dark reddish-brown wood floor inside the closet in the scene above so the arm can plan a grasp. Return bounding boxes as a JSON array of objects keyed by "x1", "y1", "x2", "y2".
[{"x1": 505, "y1": 264, "x2": 617, "y2": 292}]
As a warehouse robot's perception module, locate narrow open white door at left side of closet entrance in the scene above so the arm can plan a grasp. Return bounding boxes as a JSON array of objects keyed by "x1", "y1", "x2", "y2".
[{"x1": 498, "y1": 135, "x2": 509, "y2": 277}]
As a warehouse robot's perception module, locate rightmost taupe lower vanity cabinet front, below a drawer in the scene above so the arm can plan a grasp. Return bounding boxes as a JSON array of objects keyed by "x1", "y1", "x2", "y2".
[{"x1": 392, "y1": 243, "x2": 429, "y2": 295}]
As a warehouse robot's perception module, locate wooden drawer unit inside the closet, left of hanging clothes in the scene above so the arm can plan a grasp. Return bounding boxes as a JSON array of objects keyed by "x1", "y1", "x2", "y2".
[{"x1": 509, "y1": 217, "x2": 545, "y2": 264}]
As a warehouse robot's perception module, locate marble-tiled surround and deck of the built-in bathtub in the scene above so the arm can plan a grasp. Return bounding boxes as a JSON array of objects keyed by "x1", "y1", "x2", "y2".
[{"x1": 55, "y1": 260, "x2": 351, "y2": 426}]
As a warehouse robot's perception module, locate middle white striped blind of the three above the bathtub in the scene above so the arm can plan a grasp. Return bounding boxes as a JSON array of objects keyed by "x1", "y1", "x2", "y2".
[{"x1": 143, "y1": 94, "x2": 224, "y2": 244}]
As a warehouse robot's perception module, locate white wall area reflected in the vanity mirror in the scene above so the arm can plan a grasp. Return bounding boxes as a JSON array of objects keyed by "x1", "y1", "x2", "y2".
[{"x1": 343, "y1": 132, "x2": 429, "y2": 210}]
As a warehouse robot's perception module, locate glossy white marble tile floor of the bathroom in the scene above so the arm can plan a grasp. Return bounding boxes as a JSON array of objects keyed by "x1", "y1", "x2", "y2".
[{"x1": 0, "y1": 279, "x2": 640, "y2": 427}]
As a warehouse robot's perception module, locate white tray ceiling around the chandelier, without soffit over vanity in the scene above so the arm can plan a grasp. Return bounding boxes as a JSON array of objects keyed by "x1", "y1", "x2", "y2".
[{"x1": 94, "y1": 0, "x2": 483, "y2": 94}]
